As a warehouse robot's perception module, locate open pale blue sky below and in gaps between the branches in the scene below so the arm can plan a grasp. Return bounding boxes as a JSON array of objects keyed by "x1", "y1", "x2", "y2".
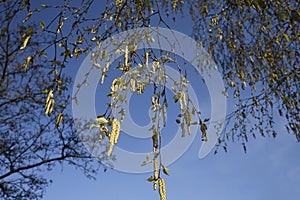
[{"x1": 43, "y1": 0, "x2": 300, "y2": 200}]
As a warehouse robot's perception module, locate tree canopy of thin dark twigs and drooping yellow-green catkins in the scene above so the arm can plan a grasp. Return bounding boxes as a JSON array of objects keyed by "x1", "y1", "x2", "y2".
[{"x1": 0, "y1": 0, "x2": 300, "y2": 199}]
